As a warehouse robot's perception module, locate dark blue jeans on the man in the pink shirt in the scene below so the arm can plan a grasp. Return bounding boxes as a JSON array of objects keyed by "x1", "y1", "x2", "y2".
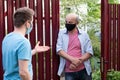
[{"x1": 65, "y1": 69, "x2": 92, "y2": 80}]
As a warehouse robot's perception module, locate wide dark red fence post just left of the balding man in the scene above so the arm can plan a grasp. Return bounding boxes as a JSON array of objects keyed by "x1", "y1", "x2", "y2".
[{"x1": 52, "y1": 0, "x2": 60, "y2": 80}]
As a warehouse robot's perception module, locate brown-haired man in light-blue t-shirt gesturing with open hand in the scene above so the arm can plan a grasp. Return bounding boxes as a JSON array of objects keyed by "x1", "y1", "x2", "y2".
[{"x1": 2, "y1": 7, "x2": 49, "y2": 80}]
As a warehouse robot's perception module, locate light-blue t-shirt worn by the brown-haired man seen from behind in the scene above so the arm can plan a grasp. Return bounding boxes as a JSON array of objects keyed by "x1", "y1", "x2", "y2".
[{"x1": 2, "y1": 32, "x2": 33, "y2": 80}]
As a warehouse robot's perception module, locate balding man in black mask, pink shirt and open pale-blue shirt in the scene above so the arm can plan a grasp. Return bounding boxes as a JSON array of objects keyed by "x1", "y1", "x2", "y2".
[{"x1": 56, "y1": 13, "x2": 93, "y2": 80}]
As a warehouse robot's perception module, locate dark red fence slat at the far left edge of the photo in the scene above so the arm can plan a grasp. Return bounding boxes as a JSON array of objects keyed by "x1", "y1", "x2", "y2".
[{"x1": 0, "y1": 0, "x2": 5, "y2": 80}]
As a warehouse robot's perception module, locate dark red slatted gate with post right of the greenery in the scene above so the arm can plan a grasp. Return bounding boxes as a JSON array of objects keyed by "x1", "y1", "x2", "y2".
[{"x1": 101, "y1": 0, "x2": 120, "y2": 80}]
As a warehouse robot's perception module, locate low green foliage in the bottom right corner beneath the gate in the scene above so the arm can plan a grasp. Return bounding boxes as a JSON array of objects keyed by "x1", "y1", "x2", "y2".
[{"x1": 107, "y1": 70, "x2": 120, "y2": 80}]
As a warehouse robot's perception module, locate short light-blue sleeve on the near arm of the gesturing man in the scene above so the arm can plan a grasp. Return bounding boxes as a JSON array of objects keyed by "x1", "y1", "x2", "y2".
[{"x1": 18, "y1": 40, "x2": 31, "y2": 60}]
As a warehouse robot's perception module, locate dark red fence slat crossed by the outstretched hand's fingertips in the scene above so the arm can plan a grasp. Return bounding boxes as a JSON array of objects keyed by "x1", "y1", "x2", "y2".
[{"x1": 44, "y1": 0, "x2": 51, "y2": 80}]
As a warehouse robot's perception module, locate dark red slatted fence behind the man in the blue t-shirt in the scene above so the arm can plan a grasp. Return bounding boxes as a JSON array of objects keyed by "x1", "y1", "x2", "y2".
[{"x1": 0, "y1": 0, "x2": 59, "y2": 80}]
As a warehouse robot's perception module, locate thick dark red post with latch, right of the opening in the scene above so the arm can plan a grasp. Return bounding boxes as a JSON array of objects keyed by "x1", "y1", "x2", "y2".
[{"x1": 101, "y1": 0, "x2": 109, "y2": 80}]
